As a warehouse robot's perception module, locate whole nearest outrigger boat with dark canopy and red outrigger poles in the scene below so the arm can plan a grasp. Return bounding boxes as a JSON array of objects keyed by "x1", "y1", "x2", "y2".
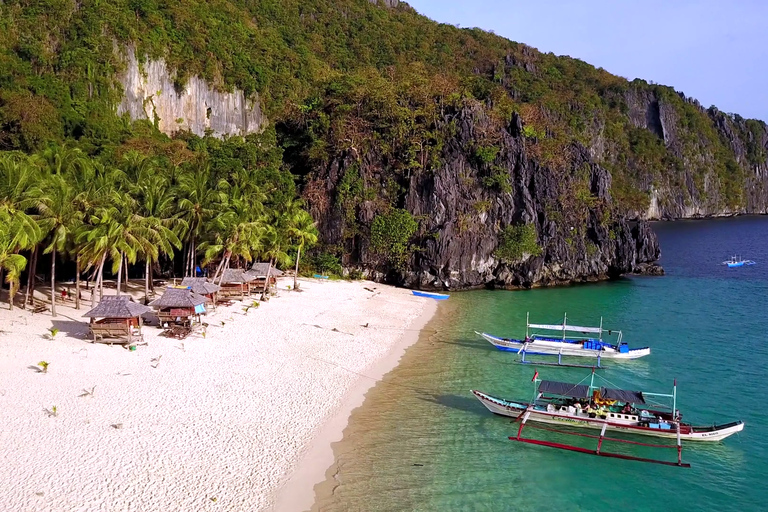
[{"x1": 472, "y1": 370, "x2": 744, "y2": 467}]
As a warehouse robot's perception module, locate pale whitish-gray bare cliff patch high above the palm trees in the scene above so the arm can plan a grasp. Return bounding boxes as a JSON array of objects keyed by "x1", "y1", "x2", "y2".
[{"x1": 117, "y1": 47, "x2": 266, "y2": 137}]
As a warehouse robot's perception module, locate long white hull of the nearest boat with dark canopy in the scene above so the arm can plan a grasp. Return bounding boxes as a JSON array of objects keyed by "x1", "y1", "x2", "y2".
[{"x1": 472, "y1": 390, "x2": 744, "y2": 442}]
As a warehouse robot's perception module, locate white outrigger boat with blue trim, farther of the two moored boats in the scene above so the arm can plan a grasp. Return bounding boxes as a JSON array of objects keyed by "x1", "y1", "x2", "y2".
[{"x1": 475, "y1": 315, "x2": 651, "y2": 359}]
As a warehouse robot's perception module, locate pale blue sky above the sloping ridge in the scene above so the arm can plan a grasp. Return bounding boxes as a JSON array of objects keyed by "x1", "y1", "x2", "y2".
[{"x1": 408, "y1": 0, "x2": 768, "y2": 121}]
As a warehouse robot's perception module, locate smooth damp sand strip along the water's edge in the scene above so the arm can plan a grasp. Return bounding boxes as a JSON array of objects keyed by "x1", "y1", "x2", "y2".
[{"x1": 273, "y1": 299, "x2": 438, "y2": 512}]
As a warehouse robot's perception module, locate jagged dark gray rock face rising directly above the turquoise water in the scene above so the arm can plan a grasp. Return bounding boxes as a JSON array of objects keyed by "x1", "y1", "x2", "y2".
[{"x1": 310, "y1": 102, "x2": 659, "y2": 289}]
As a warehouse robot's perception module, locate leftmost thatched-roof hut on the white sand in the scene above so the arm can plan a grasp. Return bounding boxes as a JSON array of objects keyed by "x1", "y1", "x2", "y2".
[{"x1": 83, "y1": 295, "x2": 152, "y2": 345}]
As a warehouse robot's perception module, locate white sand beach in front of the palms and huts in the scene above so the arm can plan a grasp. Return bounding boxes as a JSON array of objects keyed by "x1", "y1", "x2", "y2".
[{"x1": 0, "y1": 278, "x2": 436, "y2": 511}]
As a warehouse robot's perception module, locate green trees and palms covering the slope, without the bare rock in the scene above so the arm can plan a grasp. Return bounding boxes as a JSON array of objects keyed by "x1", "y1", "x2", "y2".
[{"x1": 0, "y1": 0, "x2": 766, "y2": 292}]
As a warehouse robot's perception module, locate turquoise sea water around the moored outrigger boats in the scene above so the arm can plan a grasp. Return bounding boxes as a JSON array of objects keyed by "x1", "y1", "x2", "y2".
[{"x1": 314, "y1": 217, "x2": 768, "y2": 511}]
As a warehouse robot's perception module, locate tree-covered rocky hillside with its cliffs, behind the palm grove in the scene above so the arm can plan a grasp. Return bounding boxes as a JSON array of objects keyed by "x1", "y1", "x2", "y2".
[{"x1": 0, "y1": 0, "x2": 768, "y2": 285}]
